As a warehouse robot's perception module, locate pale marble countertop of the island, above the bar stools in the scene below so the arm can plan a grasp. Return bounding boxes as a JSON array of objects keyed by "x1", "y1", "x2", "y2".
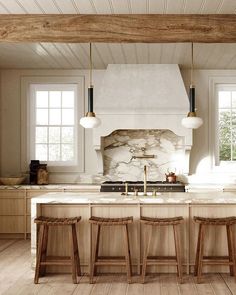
[{"x1": 31, "y1": 192, "x2": 236, "y2": 204}]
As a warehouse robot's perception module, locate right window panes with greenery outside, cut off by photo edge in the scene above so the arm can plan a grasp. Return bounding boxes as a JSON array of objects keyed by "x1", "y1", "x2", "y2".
[{"x1": 216, "y1": 84, "x2": 236, "y2": 164}]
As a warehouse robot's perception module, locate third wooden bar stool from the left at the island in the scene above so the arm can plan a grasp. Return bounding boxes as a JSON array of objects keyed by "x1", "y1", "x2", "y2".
[{"x1": 140, "y1": 216, "x2": 184, "y2": 283}]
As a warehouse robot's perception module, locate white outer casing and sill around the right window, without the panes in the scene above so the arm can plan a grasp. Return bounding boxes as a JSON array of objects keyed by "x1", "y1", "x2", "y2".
[{"x1": 209, "y1": 76, "x2": 236, "y2": 174}]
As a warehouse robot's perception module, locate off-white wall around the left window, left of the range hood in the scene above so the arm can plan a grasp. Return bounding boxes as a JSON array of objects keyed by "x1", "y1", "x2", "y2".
[{"x1": 0, "y1": 70, "x2": 103, "y2": 182}]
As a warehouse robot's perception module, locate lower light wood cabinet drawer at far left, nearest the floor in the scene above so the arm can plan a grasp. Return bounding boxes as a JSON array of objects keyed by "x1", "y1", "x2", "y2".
[{"x1": 0, "y1": 216, "x2": 25, "y2": 233}]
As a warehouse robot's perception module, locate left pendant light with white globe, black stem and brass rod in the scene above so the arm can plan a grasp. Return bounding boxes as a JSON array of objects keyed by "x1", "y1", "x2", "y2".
[{"x1": 80, "y1": 43, "x2": 101, "y2": 128}]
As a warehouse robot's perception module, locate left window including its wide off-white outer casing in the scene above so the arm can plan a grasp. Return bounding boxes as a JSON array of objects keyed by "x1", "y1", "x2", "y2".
[{"x1": 21, "y1": 75, "x2": 84, "y2": 173}]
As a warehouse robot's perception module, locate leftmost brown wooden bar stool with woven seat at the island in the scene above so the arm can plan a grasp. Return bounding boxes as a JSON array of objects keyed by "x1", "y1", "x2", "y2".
[{"x1": 34, "y1": 216, "x2": 81, "y2": 284}]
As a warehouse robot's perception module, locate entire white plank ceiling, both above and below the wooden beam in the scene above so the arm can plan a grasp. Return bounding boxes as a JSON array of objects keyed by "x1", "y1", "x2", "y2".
[{"x1": 0, "y1": 0, "x2": 236, "y2": 69}]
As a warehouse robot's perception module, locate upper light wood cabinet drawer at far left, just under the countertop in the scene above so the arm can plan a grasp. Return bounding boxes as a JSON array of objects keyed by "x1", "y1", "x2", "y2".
[{"x1": 0, "y1": 198, "x2": 24, "y2": 215}]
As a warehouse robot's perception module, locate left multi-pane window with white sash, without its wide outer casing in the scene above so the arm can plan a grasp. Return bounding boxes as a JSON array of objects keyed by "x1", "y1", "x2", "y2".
[{"x1": 30, "y1": 84, "x2": 77, "y2": 166}]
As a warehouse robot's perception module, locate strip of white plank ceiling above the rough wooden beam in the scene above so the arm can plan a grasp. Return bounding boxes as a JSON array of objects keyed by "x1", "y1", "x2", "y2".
[{"x1": 0, "y1": 0, "x2": 236, "y2": 14}]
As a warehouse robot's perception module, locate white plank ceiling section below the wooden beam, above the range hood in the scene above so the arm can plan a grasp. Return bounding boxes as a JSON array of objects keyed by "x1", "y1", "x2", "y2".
[{"x1": 0, "y1": 43, "x2": 236, "y2": 69}]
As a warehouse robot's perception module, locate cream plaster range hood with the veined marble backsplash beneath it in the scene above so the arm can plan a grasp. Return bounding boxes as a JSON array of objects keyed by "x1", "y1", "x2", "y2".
[{"x1": 93, "y1": 64, "x2": 192, "y2": 180}]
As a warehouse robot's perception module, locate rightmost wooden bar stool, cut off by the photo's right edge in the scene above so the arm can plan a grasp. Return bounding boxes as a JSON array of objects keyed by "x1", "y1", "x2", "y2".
[{"x1": 193, "y1": 216, "x2": 236, "y2": 283}]
